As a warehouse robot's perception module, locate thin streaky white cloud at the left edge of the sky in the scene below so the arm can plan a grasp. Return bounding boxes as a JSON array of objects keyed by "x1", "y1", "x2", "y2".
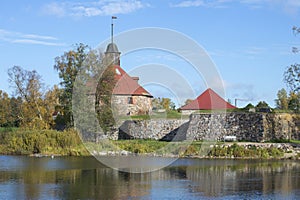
[{"x1": 0, "y1": 29, "x2": 65, "y2": 46}]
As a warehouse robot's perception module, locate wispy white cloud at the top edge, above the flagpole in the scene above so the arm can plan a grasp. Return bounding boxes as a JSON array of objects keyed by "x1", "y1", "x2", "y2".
[{"x1": 42, "y1": 0, "x2": 149, "y2": 17}]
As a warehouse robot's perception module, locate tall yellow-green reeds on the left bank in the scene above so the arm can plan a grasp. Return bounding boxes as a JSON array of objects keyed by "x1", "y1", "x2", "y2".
[{"x1": 0, "y1": 129, "x2": 87, "y2": 155}]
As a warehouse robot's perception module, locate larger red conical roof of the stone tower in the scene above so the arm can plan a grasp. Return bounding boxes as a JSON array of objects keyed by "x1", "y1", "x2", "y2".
[{"x1": 113, "y1": 65, "x2": 153, "y2": 97}]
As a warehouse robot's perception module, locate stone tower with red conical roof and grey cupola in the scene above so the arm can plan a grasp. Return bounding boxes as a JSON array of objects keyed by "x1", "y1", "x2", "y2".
[{"x1": 105, "y1": 43, "x2": 153, "y2": 115}]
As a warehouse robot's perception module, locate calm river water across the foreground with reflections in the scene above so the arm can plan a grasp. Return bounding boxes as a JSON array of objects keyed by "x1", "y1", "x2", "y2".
[{"x1": 0, "y1": 156, "x2": 300, "y2": 199}]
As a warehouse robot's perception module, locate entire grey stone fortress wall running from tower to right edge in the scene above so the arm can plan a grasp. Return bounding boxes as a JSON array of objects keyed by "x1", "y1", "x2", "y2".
[{"x1": 118, "y1": 113, "x2": 300, "y2": 142}]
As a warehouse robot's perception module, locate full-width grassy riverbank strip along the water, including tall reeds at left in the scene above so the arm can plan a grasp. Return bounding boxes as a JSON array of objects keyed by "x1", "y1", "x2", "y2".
[{"x1": 0, "y1": 129, "x2": 300, "y2": 159}]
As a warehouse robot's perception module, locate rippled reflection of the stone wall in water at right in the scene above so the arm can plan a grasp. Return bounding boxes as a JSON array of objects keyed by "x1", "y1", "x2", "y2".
[{"x1": 186, "y1": 161, "x2": 300, "y2": 196}]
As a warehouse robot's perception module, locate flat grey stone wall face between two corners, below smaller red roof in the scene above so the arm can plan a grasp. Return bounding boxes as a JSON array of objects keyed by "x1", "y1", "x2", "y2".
[{"x1": 187, "y1": 113, "x2": 264, "y2": 142}]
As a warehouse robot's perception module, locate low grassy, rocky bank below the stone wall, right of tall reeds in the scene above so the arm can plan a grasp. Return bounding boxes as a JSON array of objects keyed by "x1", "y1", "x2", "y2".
[{"x1": 87, "y1": 140, "x2": 300, "y2": 159}]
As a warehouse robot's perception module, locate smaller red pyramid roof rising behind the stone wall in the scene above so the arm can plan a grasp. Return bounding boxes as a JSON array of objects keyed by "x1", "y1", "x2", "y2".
[{"x1": 180, "y1": 88, "x2": 236, "y2": 110}]
